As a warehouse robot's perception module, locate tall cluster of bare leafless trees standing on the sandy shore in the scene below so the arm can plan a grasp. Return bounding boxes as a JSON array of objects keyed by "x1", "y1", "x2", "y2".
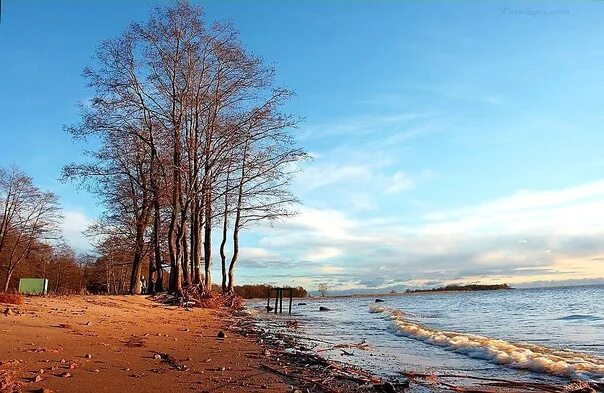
[{"x1": 63, "y1": 2, "x2": 306, "y2": 294}]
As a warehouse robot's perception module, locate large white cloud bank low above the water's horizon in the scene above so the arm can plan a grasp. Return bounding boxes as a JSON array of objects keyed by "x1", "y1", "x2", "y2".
[{"x1": 247, "y1": 181, "x2": 604, "y2": 288}]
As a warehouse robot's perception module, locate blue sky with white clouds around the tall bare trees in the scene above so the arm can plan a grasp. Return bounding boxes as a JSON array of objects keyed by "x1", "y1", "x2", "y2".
[{"x1": 0, "y1": 0, "x2": 604, "y2": 291}]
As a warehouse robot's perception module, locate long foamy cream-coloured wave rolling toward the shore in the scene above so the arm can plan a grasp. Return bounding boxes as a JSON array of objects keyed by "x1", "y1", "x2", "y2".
[{"x1": 370, "y1": 306, "x2": 604, "y2": 381}]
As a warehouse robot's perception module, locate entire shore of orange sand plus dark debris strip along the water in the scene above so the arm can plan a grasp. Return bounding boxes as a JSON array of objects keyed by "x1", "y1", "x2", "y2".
[{"x1": 0, "y1": 295, "x2": 601, "y2": 393}]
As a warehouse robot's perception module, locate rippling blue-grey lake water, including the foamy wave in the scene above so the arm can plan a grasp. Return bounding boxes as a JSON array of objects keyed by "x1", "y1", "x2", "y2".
[{"x1": 249, "y1": 286, "x2": 604, "y2": 383}]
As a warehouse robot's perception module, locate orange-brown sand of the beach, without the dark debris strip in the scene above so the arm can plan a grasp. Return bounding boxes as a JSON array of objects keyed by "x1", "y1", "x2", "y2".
[{"x1": 0, "y1": 296, "x2": 292, "y2": 392}]
